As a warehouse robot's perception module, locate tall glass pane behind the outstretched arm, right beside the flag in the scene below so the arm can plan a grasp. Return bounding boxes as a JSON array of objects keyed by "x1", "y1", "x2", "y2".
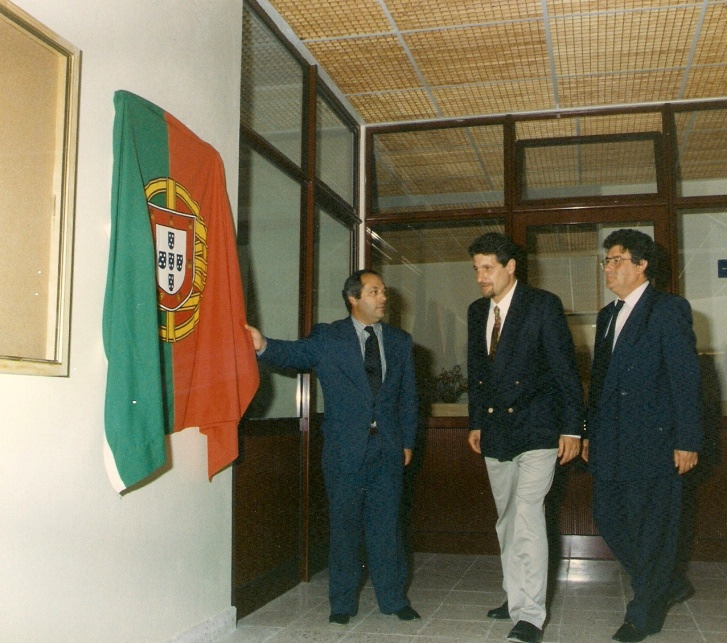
[{"x1": 238, "y1": 148, "x2": 301, "y2": 418}]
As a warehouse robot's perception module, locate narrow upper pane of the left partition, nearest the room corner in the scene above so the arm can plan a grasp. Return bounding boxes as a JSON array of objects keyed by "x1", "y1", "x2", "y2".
[{"x1": 316, "y1": 96, "x2": 355, "y2": 205}]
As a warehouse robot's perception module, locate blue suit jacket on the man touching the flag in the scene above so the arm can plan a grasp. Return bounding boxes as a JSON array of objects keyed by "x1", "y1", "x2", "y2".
[{"x1": 260, "y1": 317, "x2": 418, "y2": 471}]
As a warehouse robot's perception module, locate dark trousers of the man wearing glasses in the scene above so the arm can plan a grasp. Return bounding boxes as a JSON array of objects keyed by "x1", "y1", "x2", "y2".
[{"x1": 593, "y1": 474, "x2": 682, "y2": 632}]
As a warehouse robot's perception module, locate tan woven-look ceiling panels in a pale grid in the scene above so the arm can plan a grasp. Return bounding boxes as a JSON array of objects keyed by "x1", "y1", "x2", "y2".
[{"x1": 270, "y1": 0, "x2": 727, "y2": 125}]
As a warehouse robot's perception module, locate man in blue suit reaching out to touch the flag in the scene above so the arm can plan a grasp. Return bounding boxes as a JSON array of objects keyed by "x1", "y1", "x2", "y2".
[{"x1": 248, "y1": 270, "x2": 419, "y2": 625}]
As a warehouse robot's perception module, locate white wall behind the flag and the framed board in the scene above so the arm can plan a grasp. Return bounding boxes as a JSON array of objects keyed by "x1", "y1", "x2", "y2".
[{"x1": 0, "y1": 0, "x2": 242, "y2": 642}]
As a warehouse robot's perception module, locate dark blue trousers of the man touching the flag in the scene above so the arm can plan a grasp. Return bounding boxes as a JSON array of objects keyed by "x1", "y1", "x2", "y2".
[{"x1": 324, "y1": 435, "x2": 408, "y2": 614}]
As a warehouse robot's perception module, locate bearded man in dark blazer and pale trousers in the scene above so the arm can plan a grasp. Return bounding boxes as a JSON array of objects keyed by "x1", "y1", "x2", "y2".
[{"x1": 467, "y1": 233, "x2": 583, "y2": 643}]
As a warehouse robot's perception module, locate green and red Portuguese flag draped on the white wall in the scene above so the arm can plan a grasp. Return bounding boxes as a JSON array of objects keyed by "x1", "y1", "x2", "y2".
[{"x1": 103, "y1": 91, "x2": 258, "y2": 491}]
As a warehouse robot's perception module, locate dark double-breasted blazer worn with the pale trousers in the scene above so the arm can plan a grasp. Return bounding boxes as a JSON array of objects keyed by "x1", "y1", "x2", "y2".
[{"x1": 467, "y1": 282, "x2": 583, "y2": 461}]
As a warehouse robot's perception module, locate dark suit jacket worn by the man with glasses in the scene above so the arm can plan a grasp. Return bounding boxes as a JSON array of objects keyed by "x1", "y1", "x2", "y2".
[{"x1": 586, "y1": 286, "x2": 702, "y2": 480}]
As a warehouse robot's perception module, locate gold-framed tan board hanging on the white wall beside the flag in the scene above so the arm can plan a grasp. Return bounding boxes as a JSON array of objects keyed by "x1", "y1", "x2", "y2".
[{"x1": 0, "y1": 0, "x2": 81, "y2": 376}]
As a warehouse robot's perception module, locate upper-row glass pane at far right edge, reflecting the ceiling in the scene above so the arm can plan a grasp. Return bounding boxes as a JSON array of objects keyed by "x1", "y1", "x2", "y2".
[{"x1": 674, "y1": 109, "x2": 727, "y2": 196}]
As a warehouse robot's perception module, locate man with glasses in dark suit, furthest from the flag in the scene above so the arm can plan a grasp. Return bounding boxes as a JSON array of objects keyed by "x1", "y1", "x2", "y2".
[{"x1": 583, "y1": 229, "x2": 702, "y2": 641}]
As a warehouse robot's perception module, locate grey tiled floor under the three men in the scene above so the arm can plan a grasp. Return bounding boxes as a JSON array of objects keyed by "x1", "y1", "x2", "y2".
[{"x1": 224, "y1": 554, "x2": 727, "y2": 643}]
